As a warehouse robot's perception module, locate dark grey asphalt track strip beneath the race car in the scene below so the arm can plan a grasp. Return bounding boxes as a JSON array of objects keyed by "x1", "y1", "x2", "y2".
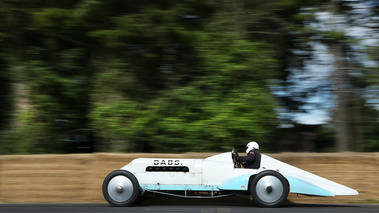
[{"x1": 0, "y1": 198, "x2": 379, "y2": 213}]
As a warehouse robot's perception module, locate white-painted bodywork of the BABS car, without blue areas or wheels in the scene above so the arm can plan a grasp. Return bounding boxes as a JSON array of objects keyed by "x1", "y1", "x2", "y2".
[{"x1": 121, "y1": 152, "x2": 358, "y2": 195}]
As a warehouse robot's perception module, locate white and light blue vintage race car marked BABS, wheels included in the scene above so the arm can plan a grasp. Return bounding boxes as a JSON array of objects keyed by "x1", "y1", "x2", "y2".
[{"x1": 102, "y1": 151, "x2": 358, "y2": 207}]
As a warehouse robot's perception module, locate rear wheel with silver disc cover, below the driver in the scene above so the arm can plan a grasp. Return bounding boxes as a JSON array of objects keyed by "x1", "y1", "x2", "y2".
[{"x1": 250, "y1": 171, "x2": 289, "y2": 207}]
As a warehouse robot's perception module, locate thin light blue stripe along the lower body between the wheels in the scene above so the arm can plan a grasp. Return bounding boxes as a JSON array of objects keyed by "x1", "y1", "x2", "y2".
[{"x1": 140, "y1": 184, "x2": 220, "y2": 191}]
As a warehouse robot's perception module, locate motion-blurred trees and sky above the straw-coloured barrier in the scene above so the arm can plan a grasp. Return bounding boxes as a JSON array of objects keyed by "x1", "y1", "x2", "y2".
[{"x1": 0, "y1": 0, "x2": 379, "y2": 154}]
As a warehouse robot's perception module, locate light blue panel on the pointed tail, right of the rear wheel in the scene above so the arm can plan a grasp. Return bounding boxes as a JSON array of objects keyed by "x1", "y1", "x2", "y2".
[{"x1": 285, "y1": 175, "x2": 335, "y2": 196}]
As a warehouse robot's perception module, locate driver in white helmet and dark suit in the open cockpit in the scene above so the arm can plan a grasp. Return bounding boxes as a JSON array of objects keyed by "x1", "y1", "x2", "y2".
[{"x1": 237, "y1": 141, "x2": 261, "y2": 169}]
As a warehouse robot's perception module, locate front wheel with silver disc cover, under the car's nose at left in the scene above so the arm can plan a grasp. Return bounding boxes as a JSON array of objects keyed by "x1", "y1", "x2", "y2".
[{"x1": 103, "y1": 170, "x2": 139, "y2": 206}]
